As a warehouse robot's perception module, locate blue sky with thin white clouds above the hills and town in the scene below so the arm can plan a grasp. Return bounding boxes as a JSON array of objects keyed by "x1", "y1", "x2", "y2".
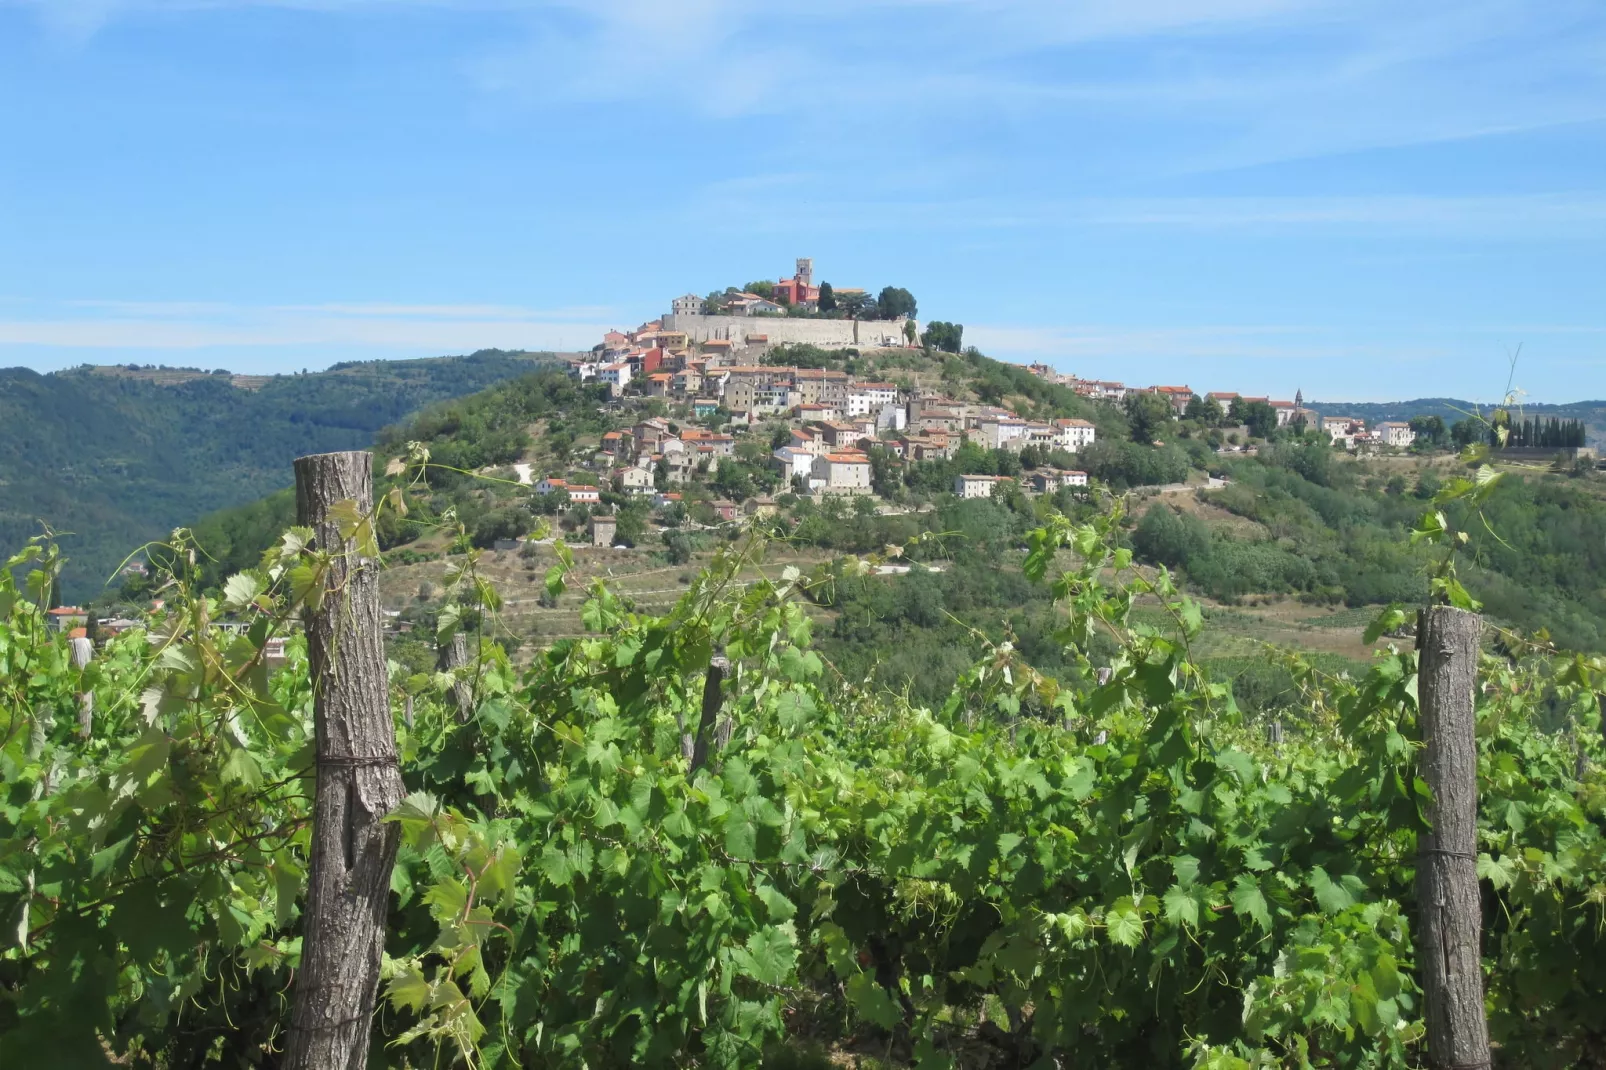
[{"x1": 0, "y1": 0, "x2": 1606, "y2": 402}]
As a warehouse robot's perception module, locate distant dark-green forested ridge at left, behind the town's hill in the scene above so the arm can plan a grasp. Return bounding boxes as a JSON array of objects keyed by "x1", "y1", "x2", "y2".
[{"x1": 0, "y1": 350, "x2": 565, "y2": 601}]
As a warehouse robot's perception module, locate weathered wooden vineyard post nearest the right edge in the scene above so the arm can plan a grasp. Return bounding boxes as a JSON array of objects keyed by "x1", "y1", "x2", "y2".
[{"x1": 1416, "y1": 606, "x2": 1490, "y2": 1070}]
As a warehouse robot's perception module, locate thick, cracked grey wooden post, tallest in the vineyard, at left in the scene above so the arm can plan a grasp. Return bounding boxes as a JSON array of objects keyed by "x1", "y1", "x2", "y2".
[{"x1": 283, "y1": 453, "x2": 405, "y2": 1070}]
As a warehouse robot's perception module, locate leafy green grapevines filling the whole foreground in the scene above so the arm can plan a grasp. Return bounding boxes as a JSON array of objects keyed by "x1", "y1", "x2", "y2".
[{"x1": 0, "y1": 455, "x2": 1606, "y2": 1070}]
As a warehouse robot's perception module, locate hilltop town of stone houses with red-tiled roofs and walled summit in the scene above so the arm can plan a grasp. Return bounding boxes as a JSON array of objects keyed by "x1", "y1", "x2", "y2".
[{"x1": 501, "y1": 259, "x2": 1471, "y2": 543}]
